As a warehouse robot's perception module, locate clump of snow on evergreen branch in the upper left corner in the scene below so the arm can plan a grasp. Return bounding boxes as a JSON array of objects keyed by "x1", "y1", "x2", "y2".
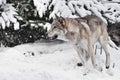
[{"x1": 0, "y1": 0, "x2": 19, "y2": 29}]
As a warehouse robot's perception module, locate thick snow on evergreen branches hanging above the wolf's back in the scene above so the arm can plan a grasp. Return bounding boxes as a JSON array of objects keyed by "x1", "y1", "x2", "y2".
[{"x1": 33, "y1": 0, "x2": 120, "y2": 23}]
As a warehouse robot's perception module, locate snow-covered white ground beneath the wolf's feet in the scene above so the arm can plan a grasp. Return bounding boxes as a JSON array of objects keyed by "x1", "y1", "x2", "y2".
[{"x1": 0, "y1": 40, "x2": 120, "y2": 80}]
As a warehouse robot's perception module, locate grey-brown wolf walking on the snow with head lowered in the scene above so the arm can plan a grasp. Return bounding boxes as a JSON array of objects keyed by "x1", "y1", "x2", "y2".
[{"x1": 48, "y1": 15, "x2": 110, "y2": 69}]
